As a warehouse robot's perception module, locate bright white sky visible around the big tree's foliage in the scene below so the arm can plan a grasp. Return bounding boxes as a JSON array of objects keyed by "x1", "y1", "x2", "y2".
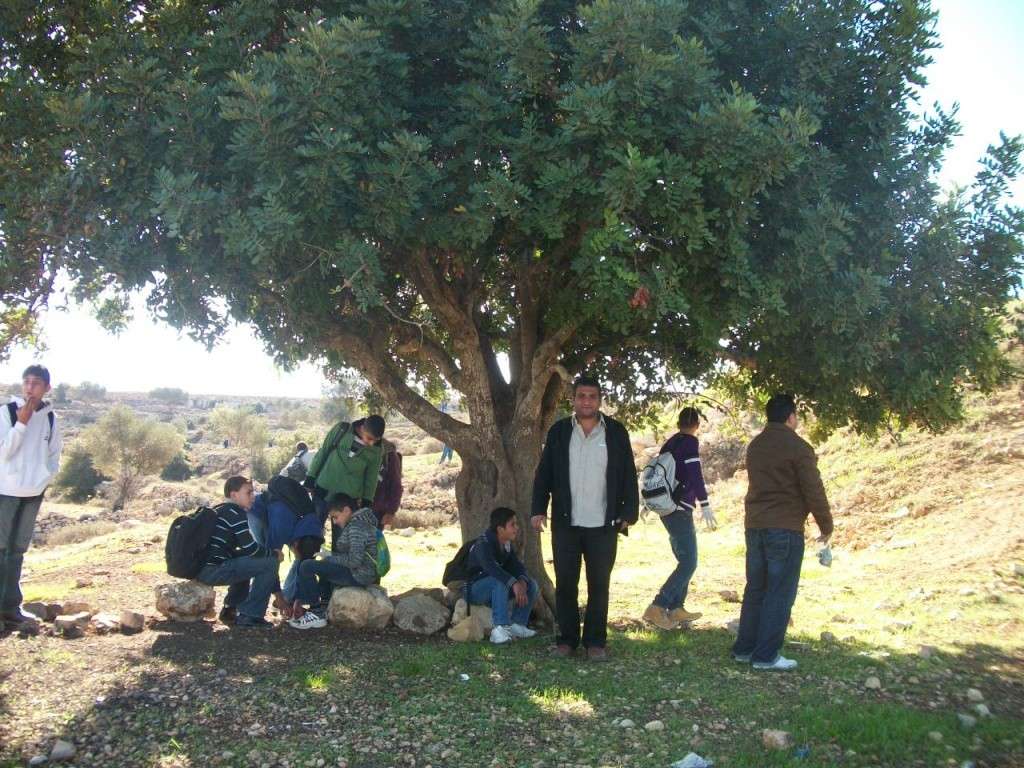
[{"x1": 0, "y1": 0, "x2": 1024, "y2": 397}]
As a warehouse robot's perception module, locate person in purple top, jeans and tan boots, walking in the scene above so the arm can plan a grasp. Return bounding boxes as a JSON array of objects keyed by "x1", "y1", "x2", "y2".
[{"x1": 643, "y1": 408, "x2": 716, "y2": 630}]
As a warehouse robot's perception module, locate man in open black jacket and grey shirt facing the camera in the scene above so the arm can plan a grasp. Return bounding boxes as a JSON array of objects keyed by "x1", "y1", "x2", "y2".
[{"x1": 530, "y1": 377, "x2": 639, "y2": 662}]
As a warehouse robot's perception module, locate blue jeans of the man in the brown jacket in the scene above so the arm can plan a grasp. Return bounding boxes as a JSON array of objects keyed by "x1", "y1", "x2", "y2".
[{"x1": 732, "y1": 528, "x2": 804, "y2": 664}]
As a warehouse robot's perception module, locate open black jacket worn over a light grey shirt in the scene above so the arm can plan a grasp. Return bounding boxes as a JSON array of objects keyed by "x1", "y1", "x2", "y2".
[{"x1": 530, "y1": 416, "x2": 640, "y2": 527}]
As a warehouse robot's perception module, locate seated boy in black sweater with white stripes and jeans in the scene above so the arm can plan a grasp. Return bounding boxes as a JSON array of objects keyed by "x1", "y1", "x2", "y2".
[{"x1": 196, "y1": 475, "x2": 281, "y2": 628}]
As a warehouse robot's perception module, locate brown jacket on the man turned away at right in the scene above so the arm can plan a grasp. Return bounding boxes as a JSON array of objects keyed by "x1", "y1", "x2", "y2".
[{"x1": 743, "y1": 422, "x2": 833, "y2": 535}]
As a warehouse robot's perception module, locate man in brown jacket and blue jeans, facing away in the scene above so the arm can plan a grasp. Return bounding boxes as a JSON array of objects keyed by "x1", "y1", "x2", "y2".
[{"x1": 732, "y1": 394, "x2": 833, "y2": 670}]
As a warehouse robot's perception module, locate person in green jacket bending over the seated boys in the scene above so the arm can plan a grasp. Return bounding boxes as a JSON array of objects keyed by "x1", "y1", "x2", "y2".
[{"x1": 305, "y1": 414, "x2": 385, "y2": 545}]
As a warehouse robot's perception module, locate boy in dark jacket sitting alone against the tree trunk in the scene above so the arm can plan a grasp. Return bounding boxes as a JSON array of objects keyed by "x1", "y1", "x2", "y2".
[{"x1": 467, "y1": 507, "x2": 539, "y2": 645}]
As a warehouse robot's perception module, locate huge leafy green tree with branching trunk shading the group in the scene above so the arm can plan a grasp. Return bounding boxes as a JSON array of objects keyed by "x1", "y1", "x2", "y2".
[{"x1": 0, "y1": 0, "x2": 1024, "y2": 581}]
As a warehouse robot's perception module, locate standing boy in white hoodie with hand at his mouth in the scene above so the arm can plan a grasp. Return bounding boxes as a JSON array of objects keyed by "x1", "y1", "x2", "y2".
[{"x1": 0, "y1": 366, "x2": 61, "y2": 630}]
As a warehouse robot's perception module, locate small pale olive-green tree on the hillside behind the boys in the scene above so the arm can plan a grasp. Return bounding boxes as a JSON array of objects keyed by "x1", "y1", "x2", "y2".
[{"x1": 82, "y1": 406, "x2": 182, "y2": 509}]
